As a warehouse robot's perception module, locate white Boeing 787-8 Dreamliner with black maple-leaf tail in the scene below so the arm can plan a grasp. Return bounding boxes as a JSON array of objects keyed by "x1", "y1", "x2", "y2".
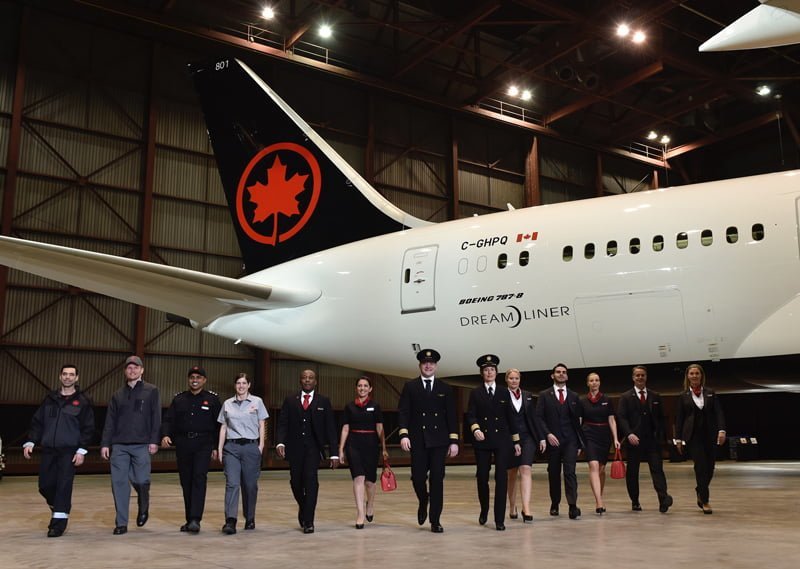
[{"x1": 0, "y1": 59, "x2": 800, "y2": 393}]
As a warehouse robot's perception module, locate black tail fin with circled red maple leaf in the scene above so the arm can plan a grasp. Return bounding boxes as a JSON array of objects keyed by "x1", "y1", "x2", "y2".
[{"x1": 190, "y1": 59, "x2": 427, "y2": 274}]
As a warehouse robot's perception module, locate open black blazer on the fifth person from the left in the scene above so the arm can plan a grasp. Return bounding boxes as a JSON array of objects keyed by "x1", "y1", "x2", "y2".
[{"x1": 275, "y1": 392, "x2": 339, "y2": 458}]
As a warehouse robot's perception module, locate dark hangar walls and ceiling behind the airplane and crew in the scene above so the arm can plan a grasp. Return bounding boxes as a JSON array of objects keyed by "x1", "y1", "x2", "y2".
[{"x1": 0, "y1": 0, "x2": 800, "y2": 472}]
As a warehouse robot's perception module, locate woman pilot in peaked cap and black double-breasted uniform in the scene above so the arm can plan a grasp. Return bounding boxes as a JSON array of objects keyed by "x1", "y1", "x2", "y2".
[{"x1": 467, "y1": 354, "x2": 522, "y2": 531}]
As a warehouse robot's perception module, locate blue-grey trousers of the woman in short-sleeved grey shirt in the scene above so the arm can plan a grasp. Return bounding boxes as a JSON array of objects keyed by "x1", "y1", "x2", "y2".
[{"x1": 222, "y1": 441, "x2": 261, "y2": 520}]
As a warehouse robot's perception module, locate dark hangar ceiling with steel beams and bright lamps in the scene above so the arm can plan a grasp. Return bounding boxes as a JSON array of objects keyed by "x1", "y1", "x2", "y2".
[{"x1": 67, "y1": 0, "x2": 800, "y2": 181}]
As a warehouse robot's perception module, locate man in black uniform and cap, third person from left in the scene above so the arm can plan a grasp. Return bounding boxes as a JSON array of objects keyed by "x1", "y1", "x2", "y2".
[{"x1": 161, "y1": 366, "x2": 222, "y2": 533}]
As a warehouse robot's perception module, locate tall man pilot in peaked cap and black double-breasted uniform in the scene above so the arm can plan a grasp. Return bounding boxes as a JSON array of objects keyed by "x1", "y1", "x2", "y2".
[{"x1": 397, "y1": 349, "x2": 458, "y2": 533}]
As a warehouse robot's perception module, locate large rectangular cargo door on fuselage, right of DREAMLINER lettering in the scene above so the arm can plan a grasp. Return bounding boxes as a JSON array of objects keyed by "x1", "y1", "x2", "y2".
[{"x1": 575, "y1": 288, "x2": 688, "y2": 366}]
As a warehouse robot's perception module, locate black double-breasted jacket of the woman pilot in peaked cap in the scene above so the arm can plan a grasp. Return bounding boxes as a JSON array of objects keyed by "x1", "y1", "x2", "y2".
[{"x1": 467, "y1": 383, "x2": 519, "y2": 449}]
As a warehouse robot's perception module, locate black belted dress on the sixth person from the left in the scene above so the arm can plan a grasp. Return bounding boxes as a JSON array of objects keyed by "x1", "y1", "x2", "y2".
[{"x1": 344, "y1": 399, "x2": 383, "y2": 482}]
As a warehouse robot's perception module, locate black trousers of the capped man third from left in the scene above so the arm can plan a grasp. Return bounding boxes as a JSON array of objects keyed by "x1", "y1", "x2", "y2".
[{"x1": 175, "y1": 433, "x2": 214, "y2": 522}]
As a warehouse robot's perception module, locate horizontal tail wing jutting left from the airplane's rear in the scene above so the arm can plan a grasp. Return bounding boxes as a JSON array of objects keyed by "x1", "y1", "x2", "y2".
[{"x1": 0, "y1": 237, "x2": 321, "y2": 326}]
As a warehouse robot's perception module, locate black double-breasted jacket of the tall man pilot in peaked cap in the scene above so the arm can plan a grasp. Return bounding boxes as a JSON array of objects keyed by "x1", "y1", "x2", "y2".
[{"x1": 397, "y1": 377, "x2": 458, "y2": 448}]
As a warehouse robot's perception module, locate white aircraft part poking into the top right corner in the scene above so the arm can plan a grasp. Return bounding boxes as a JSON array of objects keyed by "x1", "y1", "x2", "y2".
[{"x1": 699, "y1": 0, "x2": 800, "y2": 51}]
